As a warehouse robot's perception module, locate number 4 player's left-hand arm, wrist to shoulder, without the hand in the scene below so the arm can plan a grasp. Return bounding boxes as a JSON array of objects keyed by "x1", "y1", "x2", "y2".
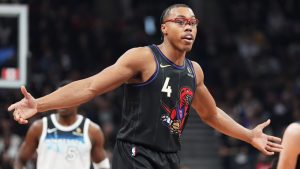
[{"x1": 36, "y1": 49, "x2": 144, "y2": 112}]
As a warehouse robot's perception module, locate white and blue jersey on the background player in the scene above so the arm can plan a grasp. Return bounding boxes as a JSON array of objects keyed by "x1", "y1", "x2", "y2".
[{"x1": 37, "y1": 114, "x2": 91, "y2": 169}]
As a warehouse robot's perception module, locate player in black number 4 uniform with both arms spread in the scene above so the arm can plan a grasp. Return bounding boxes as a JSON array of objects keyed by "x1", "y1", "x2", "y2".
[{"x1": 8, "y1": 4, "x2": 282, "y2": 169}]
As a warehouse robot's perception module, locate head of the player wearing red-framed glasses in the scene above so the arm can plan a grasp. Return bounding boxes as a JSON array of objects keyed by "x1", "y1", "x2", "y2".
[{"x1": 161, "y1": 7, "x2": 198, "y2": 51}]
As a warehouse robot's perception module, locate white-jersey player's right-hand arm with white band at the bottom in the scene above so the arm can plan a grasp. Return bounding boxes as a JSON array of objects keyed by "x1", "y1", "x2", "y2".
[{"x1": 89, "y1": 122, "x2": 110, "y2": 169}]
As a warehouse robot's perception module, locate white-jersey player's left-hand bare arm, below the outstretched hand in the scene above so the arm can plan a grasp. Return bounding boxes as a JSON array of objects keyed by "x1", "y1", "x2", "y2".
[{"x1": 14, "y1": 120, "x2": 43, "y2": 169}]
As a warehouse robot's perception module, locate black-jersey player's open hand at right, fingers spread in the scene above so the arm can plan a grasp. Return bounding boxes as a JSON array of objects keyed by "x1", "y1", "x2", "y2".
[{"x1": 250, "y1": 120, "x2": 283, "y2": 155}]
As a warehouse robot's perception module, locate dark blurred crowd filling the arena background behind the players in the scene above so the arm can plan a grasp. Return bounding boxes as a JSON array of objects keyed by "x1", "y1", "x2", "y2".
[{"x1": 0, "y1": 0, "x2": 300, "y2": 169}]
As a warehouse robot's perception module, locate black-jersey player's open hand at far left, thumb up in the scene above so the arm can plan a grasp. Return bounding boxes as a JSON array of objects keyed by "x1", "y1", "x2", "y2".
[{"x1": 7, "y1": 86, "x2": 37, "y2": 124}]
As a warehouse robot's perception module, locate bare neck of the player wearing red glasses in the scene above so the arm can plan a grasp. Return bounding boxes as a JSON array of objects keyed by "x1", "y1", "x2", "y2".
[{"x1": 158, "y1": 42, "x2": 186, "y2": 66}]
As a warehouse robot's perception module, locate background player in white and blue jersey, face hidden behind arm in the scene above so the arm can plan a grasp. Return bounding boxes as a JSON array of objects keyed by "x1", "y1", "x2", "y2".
[{"x1": 14, "y1": 82, "x2": 110, "y2": 169}]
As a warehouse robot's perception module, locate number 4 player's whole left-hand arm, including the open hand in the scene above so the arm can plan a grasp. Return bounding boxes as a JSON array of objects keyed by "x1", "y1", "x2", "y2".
[{"x1": 8, "y1": 47, "x2": 153, "y2": 124}]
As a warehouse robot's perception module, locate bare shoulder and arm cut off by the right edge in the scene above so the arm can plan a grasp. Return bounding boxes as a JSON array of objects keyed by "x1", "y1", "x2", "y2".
[{"x1": 277, "y1": 122, "x2": 300, "y2": 169}]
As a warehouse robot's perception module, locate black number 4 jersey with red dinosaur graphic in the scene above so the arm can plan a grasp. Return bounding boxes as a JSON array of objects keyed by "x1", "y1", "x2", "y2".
[{"x1": 117, "y1": 45, "x2": 196, "y2": 152}]
